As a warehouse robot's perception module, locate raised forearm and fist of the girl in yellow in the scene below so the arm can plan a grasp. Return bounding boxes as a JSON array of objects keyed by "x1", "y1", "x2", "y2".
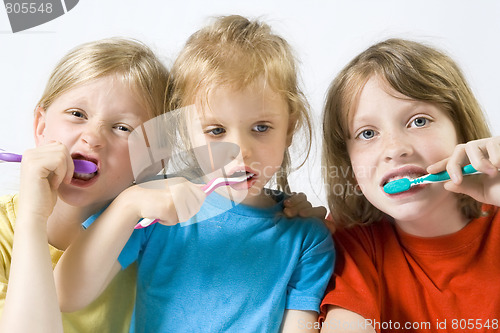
[{"x1": 0, "y1": 143, "x2": 74, "y2": 332}]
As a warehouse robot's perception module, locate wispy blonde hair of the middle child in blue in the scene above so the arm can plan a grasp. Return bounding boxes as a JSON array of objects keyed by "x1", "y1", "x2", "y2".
[{"x1": 171, "y1": 15, "x2": 311, "y2": 191}]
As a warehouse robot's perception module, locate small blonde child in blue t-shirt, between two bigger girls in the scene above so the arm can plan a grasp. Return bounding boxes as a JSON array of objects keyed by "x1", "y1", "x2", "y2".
[{"x1": 56, "y1": 16, "x2": 334, "y2": 332}]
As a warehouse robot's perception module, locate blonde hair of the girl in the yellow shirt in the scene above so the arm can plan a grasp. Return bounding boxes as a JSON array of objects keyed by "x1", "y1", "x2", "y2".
[{"x1": 38, "y1": 37, "x2": 169, "y2": 118}]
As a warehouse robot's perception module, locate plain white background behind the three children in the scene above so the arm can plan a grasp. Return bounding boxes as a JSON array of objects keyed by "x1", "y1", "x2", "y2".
[{"x1": 0, "y1": 0, "x2": 500, "y2": 205}]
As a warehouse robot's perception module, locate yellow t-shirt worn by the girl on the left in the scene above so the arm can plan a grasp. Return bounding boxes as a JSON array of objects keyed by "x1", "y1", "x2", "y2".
[{"x1": 0, "y1": 195, "x2": 137, "y2": 333}]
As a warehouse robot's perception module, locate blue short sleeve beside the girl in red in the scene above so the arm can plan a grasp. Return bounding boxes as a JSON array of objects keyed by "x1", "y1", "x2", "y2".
[{"x1": 285, "y1": 222, "x2": 335, "y2": 312}]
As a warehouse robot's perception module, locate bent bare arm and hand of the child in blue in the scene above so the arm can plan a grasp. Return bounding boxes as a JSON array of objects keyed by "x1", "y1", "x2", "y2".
[{"x1": 54, "y1": 180, "x2": 205, "y2": 312}]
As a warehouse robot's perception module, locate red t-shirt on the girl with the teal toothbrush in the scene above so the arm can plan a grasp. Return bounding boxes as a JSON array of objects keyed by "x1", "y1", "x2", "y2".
[{"x1": 321, "y1": 205, "x2": 500, "y2": 332}]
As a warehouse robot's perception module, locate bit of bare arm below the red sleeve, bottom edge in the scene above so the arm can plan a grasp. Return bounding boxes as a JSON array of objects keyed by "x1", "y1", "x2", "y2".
[{"x1": 321, "y1": 306, "x2": 375, "y2": 333}]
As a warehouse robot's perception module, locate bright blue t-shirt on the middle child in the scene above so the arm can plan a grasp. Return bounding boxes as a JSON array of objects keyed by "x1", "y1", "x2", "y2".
[{"x1": 118, "y1": 193, "x2": 335, "y2": 333}]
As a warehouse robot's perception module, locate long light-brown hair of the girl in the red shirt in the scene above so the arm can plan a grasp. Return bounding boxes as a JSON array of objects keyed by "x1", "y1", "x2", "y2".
[{"x1": 322, "y1": 39, "x2": 491, "y2": 226}]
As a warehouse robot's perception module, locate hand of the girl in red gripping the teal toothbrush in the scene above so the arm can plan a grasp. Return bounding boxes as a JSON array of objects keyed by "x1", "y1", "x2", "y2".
[{"x1": 427, "y1": 137, "x2": 500, "y2": 206}]
